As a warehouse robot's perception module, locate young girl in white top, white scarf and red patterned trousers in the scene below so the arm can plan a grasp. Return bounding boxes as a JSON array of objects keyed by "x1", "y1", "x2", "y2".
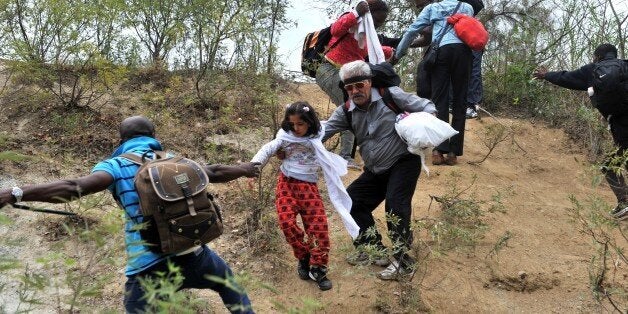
[{"x1": 251, "y1": 102, "x2": 359, "y2": 290}]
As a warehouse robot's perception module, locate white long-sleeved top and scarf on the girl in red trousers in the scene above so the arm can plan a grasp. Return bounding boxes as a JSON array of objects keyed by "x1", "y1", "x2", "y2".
[{"x1": 251, "y1": 123, "x2": 360, "y2": 239}]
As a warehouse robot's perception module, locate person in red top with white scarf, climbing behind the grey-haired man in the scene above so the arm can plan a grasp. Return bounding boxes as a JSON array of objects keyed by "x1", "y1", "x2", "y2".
[{"x1": 316, "y1": 0, "x2": 399, "y2": 168}]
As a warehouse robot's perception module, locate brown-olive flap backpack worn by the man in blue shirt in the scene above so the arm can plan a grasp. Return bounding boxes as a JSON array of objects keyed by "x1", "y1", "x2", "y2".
[{"x1": 121, "y1": 151, "x2": 223, "y2": 254}]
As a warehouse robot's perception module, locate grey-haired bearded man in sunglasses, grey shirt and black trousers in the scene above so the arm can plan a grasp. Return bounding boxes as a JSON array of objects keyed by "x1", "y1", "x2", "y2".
[{"x1": 323, "y1": 60, "x2": 436, "y2": 280}]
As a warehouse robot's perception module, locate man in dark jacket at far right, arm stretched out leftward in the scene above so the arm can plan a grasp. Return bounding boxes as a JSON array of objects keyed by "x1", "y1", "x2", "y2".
[{"x1": 532, "y1": 44, "x2": 628, "y2": 220}]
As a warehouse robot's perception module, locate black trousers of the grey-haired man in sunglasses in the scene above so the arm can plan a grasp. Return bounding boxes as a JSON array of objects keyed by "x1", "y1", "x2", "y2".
[{"x1": 347, "y1": 154, "x2": 421, "y2": 264}]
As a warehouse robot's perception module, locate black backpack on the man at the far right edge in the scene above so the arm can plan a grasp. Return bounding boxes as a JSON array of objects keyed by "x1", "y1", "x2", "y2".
[{"x1": 592, "y1": 58, "x2": 628, "y2": 116}]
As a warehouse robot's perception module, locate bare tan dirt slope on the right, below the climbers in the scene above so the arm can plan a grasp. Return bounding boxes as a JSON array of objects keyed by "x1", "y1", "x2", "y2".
[{"x1": 242, "y1": 85, "x2": 628, "y2": 313}]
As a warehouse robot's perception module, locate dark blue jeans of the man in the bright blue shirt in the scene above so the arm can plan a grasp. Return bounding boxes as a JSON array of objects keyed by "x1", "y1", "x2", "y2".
[{"x1": 124, "y1": 245, "x2": 253, "y2": 313}]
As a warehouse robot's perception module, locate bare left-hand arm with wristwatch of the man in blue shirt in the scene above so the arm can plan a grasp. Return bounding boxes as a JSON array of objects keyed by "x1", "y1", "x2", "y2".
[{"x1": 0, "y1": 171, "x2": 113, "y2": 207}]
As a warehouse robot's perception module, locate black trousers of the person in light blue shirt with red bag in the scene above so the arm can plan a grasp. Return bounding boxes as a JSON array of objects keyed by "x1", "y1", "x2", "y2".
[{"x1": 431, "y1": 44, "x2": 472, "y2": 156}]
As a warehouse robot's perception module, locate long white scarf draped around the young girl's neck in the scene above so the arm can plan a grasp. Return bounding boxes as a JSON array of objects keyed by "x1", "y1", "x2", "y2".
[{"x1": 277, "y1": 123, "x2": 360, "y2": 239}]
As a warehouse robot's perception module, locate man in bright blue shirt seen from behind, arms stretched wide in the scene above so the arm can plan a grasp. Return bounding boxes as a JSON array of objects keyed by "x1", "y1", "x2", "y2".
[{"x1": 0, "y1": 116, "x2": 259, "y2": 313}]
